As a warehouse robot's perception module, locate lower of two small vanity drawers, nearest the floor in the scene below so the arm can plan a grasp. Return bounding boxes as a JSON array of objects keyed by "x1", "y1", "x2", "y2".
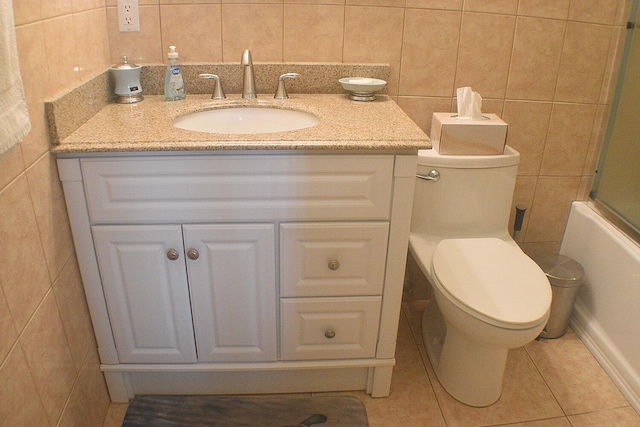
[{"x1": 280, "y1": 297, "x2": 382, "y2": 360}]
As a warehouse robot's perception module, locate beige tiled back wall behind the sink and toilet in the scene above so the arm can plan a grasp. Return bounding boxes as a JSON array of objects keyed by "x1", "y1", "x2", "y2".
[{"x1": 107, "y1": 0, "x2": 629, "y2": 252}]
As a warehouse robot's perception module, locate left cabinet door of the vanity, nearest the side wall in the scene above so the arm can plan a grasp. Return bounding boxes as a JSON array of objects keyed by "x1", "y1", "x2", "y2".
[{"x1": 93, "y1": 225, "x2": 196, "y2": 363}]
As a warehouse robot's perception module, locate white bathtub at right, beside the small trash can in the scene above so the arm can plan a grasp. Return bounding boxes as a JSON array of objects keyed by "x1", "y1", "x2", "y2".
[{"x1": 560, "y1": 202, "x2": 640, "y2": 413}]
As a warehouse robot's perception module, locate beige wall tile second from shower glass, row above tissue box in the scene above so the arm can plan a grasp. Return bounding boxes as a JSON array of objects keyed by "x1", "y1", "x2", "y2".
[{"x1": 507, "y1": 17, "x2": 566, "y2": 101}]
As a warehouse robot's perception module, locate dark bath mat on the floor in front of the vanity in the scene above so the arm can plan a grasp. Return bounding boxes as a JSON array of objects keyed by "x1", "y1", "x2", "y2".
[{"x1": 122, "y1": 396, "x2": 369, "y2": 427}]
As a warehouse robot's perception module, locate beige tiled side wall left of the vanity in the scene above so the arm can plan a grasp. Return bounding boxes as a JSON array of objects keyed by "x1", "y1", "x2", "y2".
[{"x1": 0, "y1": 0, "x2": 111, "y2": 426}]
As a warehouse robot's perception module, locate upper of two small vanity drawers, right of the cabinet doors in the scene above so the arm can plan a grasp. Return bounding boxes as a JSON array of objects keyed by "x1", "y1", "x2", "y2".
[{"x1": 280, "y1": 222, "x2": 389, "y2": 297}]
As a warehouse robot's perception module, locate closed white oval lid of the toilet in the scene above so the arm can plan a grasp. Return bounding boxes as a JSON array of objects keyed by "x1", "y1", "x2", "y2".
[{"x1": 432, "y1": 238, "x2": 551, "y2": 329}]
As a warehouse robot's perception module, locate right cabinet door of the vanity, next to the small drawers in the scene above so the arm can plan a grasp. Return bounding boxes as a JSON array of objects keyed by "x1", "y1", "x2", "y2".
[{"x1": 183, "y1": 224, "x2": 277, "y2": 362}]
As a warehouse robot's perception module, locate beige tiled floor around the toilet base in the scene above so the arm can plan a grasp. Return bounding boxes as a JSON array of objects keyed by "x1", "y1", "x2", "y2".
[{"x1": 104, "y1": 298, "x2": 640, "y2": 427}]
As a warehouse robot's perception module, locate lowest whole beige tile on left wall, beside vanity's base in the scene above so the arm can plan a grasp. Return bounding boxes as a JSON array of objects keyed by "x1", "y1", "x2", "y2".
[{"x1": 20, "y1": 292, "x2": 77, "y2": 425}]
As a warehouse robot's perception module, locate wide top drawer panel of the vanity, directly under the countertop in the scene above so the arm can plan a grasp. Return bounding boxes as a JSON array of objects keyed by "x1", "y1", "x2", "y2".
[{"x1": 82, "y1": 154, "x2": 394, "y2": 224}]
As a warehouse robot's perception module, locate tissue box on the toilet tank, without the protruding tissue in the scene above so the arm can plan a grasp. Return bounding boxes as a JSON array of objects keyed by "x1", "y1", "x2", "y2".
[{"x1": 431, "y1": 113, "x2": 507, "y2": 155}]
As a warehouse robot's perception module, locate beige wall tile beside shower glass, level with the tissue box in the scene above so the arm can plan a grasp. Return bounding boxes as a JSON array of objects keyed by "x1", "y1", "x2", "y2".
[{"x1": 540, "y1": 104, "x2": 597, "y2": 176}]
